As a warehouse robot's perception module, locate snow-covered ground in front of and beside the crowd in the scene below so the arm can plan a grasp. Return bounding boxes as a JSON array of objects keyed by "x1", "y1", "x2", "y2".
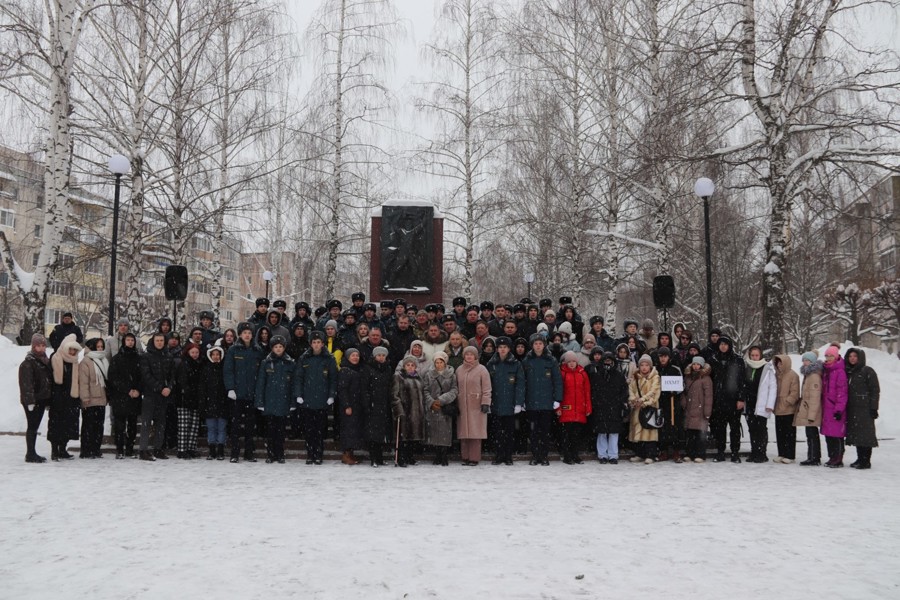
[{"x1": 0, "y1": 340, "x2": 900, "y2": 600}]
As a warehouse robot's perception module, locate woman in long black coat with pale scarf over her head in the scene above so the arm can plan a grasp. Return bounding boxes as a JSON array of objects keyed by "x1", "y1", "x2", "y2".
[{"x1": 47, "y1": 333, "x2": 81, "y2": 460}]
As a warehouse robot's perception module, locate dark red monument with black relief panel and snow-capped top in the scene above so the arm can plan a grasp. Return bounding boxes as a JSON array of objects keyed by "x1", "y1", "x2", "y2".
[{"x1": 369, "y1": 200, "x2": 444, "y2": 308}]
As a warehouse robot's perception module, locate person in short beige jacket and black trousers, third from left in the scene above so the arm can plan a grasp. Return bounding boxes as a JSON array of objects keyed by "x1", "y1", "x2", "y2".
[{"x1": 78, "y1": 338, "x2": 109, "y2": 458}]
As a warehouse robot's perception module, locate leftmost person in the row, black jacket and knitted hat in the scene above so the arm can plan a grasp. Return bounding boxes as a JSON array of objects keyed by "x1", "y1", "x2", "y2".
[{"x1": 19, "y1": 333, "x2": 53, "y2": 463}]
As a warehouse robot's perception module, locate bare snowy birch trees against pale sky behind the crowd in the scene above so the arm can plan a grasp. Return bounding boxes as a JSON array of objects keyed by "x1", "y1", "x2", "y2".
[{"x1": 0, "y1": 0, "x2": 900, "y2": 350}]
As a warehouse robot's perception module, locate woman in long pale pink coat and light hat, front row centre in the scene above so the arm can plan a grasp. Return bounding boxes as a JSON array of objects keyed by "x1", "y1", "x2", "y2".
[{"x1": 456, "y1": 346, "x2": 491, "y2": 467}]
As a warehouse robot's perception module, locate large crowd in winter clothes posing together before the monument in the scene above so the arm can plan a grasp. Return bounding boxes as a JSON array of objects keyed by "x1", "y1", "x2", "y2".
[{"x1": 19, "y1": 292, "x2": 879, "y2": 469}]
